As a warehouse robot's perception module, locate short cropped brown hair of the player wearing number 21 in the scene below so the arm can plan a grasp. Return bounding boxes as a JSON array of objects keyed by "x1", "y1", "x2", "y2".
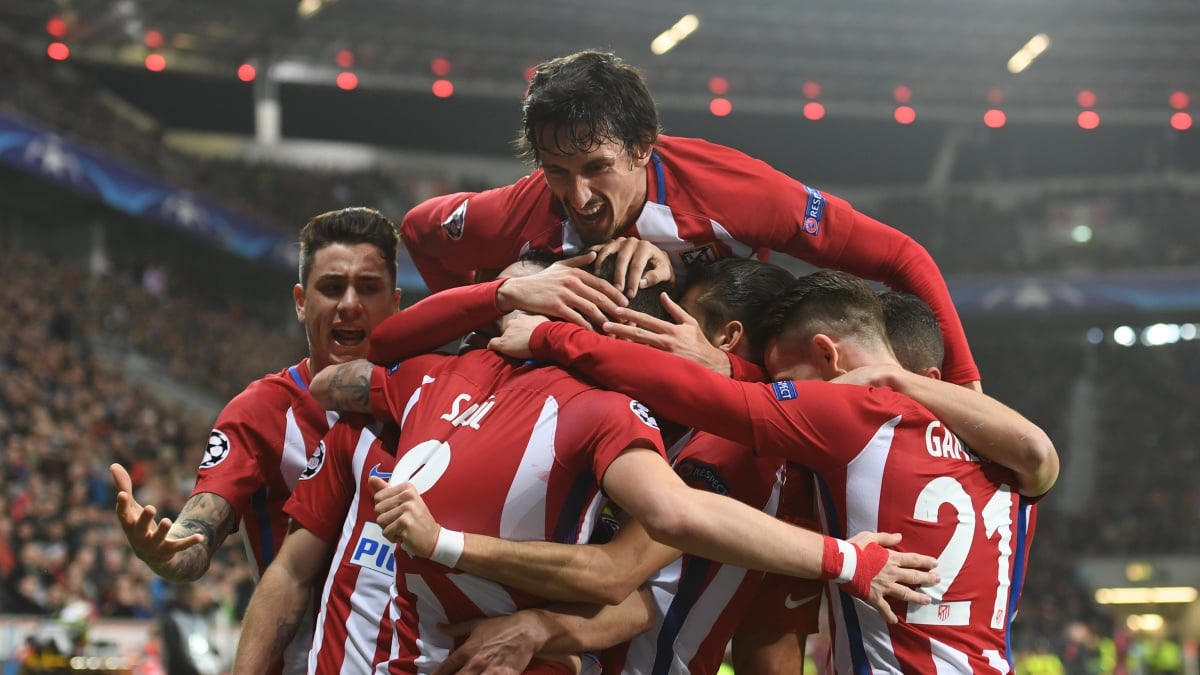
[{"x1": 760, "y1": 270, "x2": 888, "y2": 346}]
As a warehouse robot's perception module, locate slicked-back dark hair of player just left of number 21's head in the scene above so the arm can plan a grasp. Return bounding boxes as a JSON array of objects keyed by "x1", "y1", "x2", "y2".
[{"x1": 688, "y1": 257, "x2": 796, "y2": 360}]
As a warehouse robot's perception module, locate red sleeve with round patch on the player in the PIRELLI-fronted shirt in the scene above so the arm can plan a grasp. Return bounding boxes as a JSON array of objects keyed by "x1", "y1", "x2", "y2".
[{"x1": 283, "y1": 422, "x2": 360, "y2": 544}]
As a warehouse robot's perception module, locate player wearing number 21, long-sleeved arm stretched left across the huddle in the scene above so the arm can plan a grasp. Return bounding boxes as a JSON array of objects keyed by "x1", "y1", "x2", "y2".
[{"x1": 493, "y1": 271, "x2": 1058, "y2": 673}]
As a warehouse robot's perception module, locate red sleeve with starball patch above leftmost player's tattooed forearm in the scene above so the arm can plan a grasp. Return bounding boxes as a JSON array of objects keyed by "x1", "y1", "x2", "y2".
[{"x1": 192, "y1": 381, "x2": 292, "y2": 522}]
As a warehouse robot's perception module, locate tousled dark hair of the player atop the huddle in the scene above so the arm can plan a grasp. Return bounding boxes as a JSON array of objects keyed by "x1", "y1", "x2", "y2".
[{"x1": 516, "y1": 49, "x2": 659, "y2": 166}]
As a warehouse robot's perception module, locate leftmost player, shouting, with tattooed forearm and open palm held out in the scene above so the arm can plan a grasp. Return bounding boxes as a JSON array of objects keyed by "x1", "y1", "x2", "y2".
[{"x1": 110, "y1": 208, "x2": 400, "y2": 673}]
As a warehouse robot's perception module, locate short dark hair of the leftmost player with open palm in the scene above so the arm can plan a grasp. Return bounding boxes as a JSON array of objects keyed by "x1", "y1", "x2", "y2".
[{"x1": 300, "y1": 207, "x2": 400, "y2": 287}]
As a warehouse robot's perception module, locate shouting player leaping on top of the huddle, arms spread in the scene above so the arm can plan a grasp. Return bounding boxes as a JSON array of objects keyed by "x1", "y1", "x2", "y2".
[{"x1": 401, "y1": 50, "x2": 979, "y2": 383}]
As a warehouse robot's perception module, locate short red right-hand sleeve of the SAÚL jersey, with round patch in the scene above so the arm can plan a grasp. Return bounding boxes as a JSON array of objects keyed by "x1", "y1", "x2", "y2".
[{"x1": 554, "y1": 389, "x2": 666, "y2": 483}]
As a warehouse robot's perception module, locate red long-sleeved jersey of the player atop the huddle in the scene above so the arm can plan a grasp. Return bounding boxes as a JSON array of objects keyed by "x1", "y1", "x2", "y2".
[{"x1": 400, "y1": 136, "x2": 979, "y2": 382}]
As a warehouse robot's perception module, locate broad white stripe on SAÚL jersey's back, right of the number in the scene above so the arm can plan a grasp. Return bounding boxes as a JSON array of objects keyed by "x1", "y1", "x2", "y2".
[{"x1": 499, "y1": 396, "x2": 558, "y2": 540}]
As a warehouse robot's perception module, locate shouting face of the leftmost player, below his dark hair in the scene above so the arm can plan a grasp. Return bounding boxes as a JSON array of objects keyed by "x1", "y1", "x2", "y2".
[{"x1": 294, "y1": 244, "x2": 400, "y2": 374}]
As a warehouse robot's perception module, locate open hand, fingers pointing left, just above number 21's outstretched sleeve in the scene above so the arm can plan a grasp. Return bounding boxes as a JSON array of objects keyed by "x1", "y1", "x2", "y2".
[{"x1": 600, "y1": 293, "x2": 732, "y2": 376}]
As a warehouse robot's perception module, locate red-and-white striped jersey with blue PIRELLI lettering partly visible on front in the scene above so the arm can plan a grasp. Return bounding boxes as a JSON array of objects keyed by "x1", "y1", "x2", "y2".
[{"x1": 286, "y1": 416, "x2": 408, "y2": 673}]
